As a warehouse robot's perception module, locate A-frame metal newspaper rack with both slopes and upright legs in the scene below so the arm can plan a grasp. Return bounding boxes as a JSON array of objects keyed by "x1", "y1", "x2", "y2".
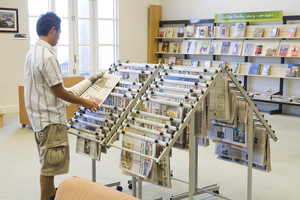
[{"x1": 108, "y1": 66, "x2": 277, "y2": 200}]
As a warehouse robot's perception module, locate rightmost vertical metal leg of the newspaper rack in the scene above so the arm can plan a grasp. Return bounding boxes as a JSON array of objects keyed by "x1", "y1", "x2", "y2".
[{"x1": 247, "y1": 105, "x2": 254, "y2": 200}]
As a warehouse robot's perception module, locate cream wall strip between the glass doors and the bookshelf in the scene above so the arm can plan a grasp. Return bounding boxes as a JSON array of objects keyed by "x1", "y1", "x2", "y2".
[{"x1": 119, "y1": 0, "x2": 160, "y2": 62}]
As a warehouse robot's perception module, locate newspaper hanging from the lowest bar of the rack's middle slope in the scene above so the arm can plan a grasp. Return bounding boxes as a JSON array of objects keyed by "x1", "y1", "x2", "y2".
[{"x1": 121, "y1": 135, "x2": 156, "y2": 178}]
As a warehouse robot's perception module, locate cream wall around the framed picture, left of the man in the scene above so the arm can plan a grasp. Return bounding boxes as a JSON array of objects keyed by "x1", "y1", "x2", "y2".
[{"x1": 0, "y1": 0, "x2": 29, "y2": 112}]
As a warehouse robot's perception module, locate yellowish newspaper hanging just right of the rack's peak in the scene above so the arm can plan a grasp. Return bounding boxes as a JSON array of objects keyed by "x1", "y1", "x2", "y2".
[{"x1": 209, "y1": 73, "x2": 230, "y2": 121}]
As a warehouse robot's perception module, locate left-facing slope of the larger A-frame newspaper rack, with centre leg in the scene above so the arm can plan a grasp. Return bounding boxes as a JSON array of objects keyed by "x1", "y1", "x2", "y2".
[{"x1": 108, "y1": 63, "x2": 222, "y2": 199}]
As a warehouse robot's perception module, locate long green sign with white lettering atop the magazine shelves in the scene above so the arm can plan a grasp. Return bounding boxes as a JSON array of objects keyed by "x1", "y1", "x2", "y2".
[{"x1": 215, "y1": 11, "x2": 283, "y2": 23}]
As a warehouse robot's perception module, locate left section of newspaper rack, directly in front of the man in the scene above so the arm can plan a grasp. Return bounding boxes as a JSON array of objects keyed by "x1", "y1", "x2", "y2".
[{"x1": 68, "y1": 63, "x2": 161, "y2": 186}]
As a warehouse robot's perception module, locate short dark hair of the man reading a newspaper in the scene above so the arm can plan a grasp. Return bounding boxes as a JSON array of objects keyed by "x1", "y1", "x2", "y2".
[{"x1": 36, "y1": 12, "x2": 61, "y2": 36}]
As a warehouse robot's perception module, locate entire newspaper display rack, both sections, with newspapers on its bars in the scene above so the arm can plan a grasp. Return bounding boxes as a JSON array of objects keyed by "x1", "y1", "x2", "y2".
[{"x1": 69, "y1": 61, "x2": 277, "y2": 200}]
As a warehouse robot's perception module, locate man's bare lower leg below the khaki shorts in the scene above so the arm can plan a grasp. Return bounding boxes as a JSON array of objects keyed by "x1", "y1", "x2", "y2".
[{"x1": 40, "y1": 175, "x2": 56, "y2": 200}]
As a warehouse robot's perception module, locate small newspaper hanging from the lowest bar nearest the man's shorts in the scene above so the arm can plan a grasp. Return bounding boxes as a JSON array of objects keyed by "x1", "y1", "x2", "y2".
[{"x1": 76, "y1": 132, "x2": 101, "y2": 161}]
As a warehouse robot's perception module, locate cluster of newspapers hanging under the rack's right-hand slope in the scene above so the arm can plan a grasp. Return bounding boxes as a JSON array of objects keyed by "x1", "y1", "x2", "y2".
[{"x1": 208, "y1": 72, "x2": 271, "y2": 172}]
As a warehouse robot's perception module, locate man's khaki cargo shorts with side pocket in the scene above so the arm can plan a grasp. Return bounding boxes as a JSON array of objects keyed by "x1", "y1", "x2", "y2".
[{"x1": 35, "y1": 124, "x2": 70, "y2": 176}]
